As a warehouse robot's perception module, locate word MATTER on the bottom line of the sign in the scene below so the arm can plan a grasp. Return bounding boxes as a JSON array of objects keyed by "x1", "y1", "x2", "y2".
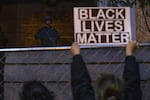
[{"x1": 76, "y1": 32, "x2": 130, "y2": 44}]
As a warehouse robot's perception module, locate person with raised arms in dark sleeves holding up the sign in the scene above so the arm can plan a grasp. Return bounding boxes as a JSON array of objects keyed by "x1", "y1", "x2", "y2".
[{"x1": 71, "y1": 41, "x2": 142, "y2": 100}]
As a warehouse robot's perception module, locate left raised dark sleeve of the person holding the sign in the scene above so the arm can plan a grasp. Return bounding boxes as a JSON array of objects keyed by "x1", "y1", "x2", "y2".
[{"x1": 71, "y1": 55, "x2": 95, "y2": 100}]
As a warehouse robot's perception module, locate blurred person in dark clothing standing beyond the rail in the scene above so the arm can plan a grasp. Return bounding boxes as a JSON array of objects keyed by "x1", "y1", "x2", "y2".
[{"x1": 35, "y1": 16, "x2": 59, "y2": 46}]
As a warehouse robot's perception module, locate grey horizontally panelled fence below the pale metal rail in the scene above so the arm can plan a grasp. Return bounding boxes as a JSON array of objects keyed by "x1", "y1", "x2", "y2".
[{"x1": 1, "y1": 47, "x2": 150, "y2": 100}]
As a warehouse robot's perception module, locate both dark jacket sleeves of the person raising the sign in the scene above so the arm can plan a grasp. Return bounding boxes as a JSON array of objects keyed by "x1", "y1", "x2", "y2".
[{"x1": 71, "y1": 55, "x2": 141, "y2": 100}]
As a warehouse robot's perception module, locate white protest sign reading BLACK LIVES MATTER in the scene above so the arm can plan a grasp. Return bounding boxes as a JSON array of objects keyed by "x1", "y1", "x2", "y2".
[{"x1": 74, "y1": 7, "x2": 132, "y2": 46}]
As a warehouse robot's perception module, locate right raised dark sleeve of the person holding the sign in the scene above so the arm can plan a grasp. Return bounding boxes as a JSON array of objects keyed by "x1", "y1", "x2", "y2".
[{"x1": 123, "y1": 56, "x2": 142, "y2": 100}]
